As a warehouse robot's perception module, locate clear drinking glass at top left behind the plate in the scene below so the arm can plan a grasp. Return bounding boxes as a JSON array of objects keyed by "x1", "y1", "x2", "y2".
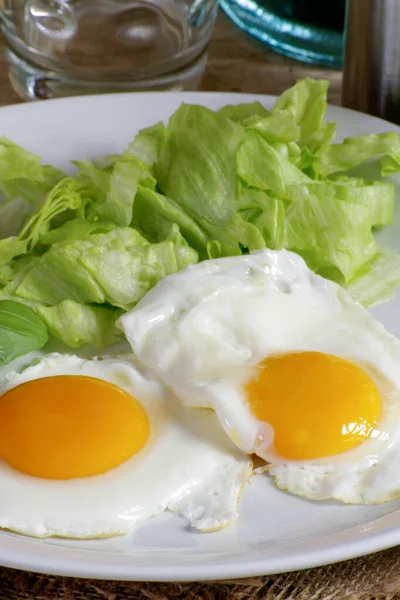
[{"x1": 0, "y1": 0, "x2": 218, "y2": 100}]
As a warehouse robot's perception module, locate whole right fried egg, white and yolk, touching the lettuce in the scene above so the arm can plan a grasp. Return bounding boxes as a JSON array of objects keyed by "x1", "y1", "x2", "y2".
[{"x1": 120, "y1": 250, "x2": 400, "y2": 504}]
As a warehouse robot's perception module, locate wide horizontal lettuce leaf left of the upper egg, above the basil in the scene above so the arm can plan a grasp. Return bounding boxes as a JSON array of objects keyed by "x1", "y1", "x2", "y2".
[{"x1": 11, "y1": 227, "x2": 198, "y2": 309}]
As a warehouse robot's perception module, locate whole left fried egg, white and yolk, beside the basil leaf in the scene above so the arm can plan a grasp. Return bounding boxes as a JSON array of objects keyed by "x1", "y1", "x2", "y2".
[{"x1": 0, "y1": 354, "x2": 252, "y2": 538}]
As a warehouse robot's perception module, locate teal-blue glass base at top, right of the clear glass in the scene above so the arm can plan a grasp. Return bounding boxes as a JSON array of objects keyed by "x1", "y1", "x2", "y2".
[{"x1": 220, "y1": 0, "x2": 346, "y2": 67}]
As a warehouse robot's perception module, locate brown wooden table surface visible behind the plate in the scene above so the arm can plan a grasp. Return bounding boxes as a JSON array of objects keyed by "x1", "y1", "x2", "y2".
[{"x1": 0, "y1": 12, "x2": 342, "y2": 106}]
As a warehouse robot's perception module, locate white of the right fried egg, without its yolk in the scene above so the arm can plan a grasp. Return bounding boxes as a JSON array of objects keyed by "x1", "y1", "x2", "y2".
[{"x1": 120, "y1": 250, "x2": 400, "y2": 504}]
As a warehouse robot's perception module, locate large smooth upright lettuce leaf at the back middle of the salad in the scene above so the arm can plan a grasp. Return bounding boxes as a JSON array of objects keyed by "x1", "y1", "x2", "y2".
[{"x1": 155, "y1": 104, "x2": 243, "y2": 225}]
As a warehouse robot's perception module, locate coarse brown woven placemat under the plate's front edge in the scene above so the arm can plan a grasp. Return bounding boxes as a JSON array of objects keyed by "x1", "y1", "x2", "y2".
[{"x1": 0, "y1": 547, "x2": 400, "y2": 600}]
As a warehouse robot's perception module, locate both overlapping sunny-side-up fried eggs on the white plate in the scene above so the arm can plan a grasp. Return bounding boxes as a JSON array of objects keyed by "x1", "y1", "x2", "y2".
[{"x1": 0, "y1": 250, "x2": 400, "y2": 538}]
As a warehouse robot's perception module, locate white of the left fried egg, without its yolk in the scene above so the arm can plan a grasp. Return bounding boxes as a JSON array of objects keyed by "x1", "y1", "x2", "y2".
[{"x1": 0, "y1": 354, "x2": 252, "y2": 538}]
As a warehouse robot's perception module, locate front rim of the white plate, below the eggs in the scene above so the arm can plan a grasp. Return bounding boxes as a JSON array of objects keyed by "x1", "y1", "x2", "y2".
[{"x1": 0, "y1": 511, "x2": 400, "y2": 582}]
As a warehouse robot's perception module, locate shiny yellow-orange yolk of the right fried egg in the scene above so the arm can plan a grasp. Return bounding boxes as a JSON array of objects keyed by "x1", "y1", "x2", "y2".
[{"x1": 245, "y1": 352, "x2": 381, "y2": 460}]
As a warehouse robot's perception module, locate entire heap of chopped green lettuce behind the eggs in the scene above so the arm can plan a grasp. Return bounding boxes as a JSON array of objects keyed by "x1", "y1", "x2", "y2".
[{"x1": 0, "y1": 79, "x2": 400, "y2": 348}]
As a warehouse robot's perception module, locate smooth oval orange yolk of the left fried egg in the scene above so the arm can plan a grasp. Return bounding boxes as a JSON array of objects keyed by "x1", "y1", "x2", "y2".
[{"x1": 0, "y1": 375, "x2": 150, "y2": 479}]
